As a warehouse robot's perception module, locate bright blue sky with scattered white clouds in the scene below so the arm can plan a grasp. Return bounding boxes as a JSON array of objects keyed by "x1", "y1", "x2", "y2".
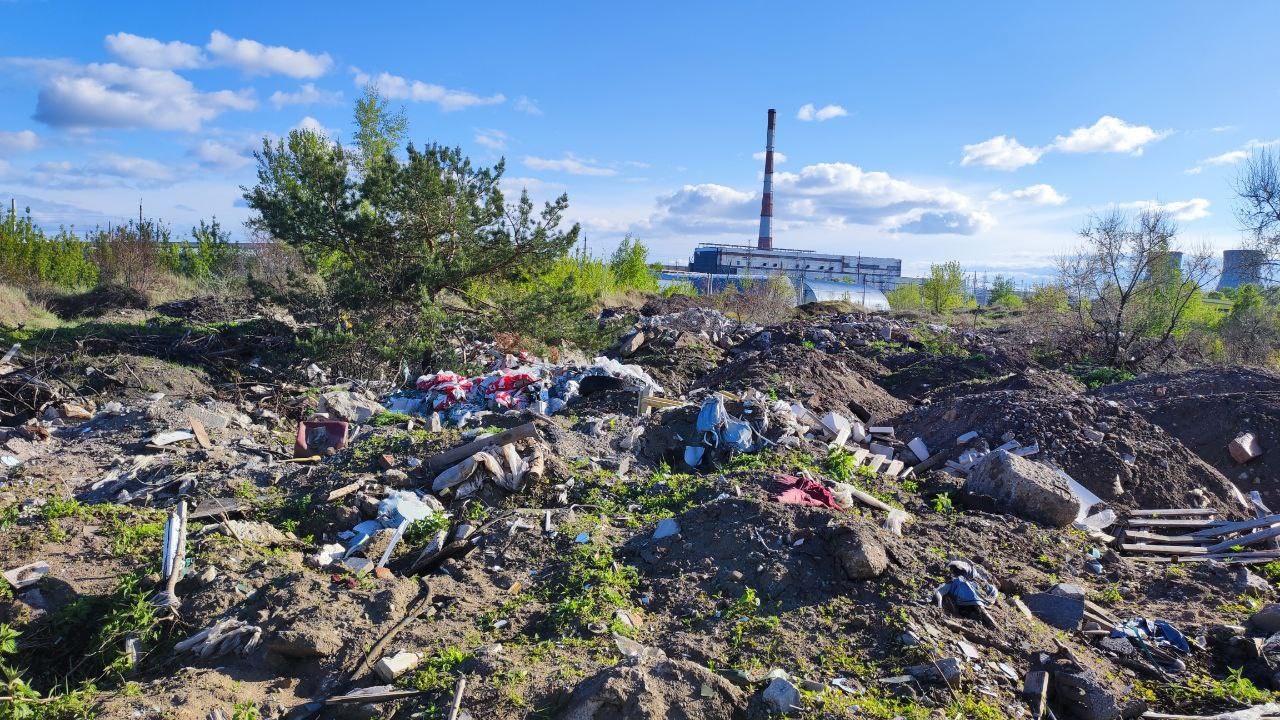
[{"x1": 0, "y1": 0, "x2": 1280, "y2": 278}]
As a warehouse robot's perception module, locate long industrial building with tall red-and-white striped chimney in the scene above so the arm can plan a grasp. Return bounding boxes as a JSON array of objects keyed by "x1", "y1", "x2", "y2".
[{"x1": 668, "y1": 109, "x2": 904, "y2": 297}]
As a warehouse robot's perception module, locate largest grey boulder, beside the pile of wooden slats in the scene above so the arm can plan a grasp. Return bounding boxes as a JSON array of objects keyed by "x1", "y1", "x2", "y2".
[{"x1": 964, "y1": 450, "x2": 1080, "y2": 528}]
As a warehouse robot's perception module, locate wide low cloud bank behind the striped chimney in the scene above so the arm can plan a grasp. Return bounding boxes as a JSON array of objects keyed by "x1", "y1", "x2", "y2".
[{"x1": 649, "y1": 163, "x2": 995, "y2": 234}]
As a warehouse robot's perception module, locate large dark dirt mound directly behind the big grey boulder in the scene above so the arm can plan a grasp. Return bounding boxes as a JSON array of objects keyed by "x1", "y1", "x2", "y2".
[{"x1": 896, "y1": 391, "x2": 1238, "y2": 511}]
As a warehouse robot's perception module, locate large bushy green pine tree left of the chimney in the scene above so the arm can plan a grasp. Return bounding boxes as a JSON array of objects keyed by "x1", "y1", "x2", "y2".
[{"x1": 243, "y1": 91, "x2": 580, "y2": 323}]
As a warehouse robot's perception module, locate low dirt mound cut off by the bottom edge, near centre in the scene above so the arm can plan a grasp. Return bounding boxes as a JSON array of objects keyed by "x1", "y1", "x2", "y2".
[{"x1": 558, "y1": 660, "x2": 746, "y2": 720}]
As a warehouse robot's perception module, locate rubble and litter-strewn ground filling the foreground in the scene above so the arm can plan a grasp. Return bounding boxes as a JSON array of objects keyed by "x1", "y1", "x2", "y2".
[{"x1": 0, "y1": 305, "x2": 1280, "y2": 720}]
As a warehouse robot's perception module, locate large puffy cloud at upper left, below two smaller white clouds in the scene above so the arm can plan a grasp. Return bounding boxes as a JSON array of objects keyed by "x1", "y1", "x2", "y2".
[{"x1": 33, "y1": 63, "x2": 256, "y2": 132}]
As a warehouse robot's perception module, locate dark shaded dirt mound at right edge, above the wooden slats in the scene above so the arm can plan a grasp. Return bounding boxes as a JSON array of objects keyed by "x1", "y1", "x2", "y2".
[{"x1": 1094, "y1": 368, "x2": 1280, "y2": 507}]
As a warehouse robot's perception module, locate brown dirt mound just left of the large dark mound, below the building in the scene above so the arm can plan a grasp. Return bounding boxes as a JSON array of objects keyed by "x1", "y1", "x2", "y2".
[{"x1": 696, "y1": 345, "x2": 908, "y2": 421}]
